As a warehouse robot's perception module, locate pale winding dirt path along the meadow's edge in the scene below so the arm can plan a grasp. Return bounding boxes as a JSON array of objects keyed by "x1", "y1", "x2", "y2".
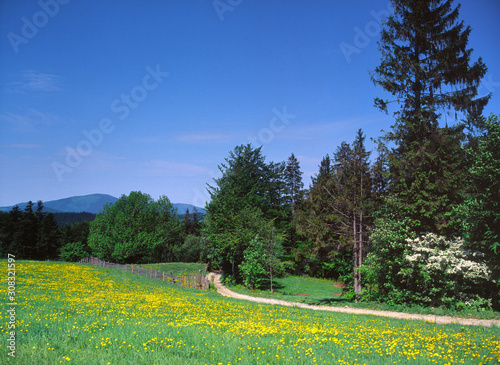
[{"x1": 207, "y1": 272, "x2": 500, "y2": 327}]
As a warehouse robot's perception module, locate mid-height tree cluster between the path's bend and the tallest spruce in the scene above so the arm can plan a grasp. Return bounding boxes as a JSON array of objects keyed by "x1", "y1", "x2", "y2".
[{"x1": 202, "y1": 141, "x2": 374, "y2": 287}]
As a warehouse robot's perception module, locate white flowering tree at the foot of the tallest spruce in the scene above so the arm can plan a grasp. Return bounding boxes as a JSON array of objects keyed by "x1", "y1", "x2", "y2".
[{"x1": 398, "y1": 233, "x2": 491, "y2": 309}]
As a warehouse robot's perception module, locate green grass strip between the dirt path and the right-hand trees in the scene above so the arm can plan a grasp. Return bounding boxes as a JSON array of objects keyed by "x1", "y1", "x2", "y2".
[{"x1": 228, "y1": 276, "x2": 500, "y2": 319}]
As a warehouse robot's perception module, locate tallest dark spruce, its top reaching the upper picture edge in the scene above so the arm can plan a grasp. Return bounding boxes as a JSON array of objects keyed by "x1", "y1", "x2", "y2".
[{"x1": 372, "y1": 0, "x2": 490, "y2": 235}]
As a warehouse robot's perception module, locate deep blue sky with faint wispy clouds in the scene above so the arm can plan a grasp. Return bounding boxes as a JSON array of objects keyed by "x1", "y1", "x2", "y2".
[{"x1": 0, "y1": 0, "x2": 500, "y2": 206}]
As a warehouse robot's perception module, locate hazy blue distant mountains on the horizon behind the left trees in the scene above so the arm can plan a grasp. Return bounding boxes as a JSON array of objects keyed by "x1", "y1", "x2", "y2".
[{"x1": 0, "y1": 194, "x2": 206, "y2": 215}]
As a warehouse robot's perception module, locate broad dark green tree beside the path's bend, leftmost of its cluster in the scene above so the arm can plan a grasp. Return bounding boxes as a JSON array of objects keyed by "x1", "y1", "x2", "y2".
[{"x1": 203, "y1": 144, "x2": 286, "y2": 280}]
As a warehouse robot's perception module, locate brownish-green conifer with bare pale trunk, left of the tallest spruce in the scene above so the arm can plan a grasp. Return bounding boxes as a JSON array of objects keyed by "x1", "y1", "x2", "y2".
[{"x1": 297, "y1": 129, "x2": 373, "y2": 293}]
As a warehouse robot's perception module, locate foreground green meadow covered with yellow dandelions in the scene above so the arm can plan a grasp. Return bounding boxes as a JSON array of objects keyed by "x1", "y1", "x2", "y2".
[{"x1": 0, "y1": 261, "x2": 500, "y2": 365}]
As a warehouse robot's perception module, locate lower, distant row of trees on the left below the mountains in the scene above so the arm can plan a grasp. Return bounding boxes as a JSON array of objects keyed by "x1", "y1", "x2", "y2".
[{"x1": 0, "y1": 192, "x2": 206, "y2": 263}]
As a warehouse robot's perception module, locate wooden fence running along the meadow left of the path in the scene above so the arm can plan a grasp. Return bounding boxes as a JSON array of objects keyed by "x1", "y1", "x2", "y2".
[{"x1": 79, "y1": 257, "x2": 210, "y2": 290}]
